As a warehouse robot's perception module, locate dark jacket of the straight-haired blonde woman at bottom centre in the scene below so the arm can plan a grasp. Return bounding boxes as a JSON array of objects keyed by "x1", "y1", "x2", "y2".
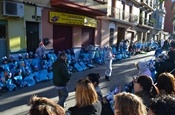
[{"x1": 68, "y1": 101, "x2": 102, "y2": 115}]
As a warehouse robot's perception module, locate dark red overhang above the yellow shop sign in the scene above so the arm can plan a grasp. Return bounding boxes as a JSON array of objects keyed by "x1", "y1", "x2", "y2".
[{"x1": 50, "y1": 0, "x2": 107, "y2": 16}]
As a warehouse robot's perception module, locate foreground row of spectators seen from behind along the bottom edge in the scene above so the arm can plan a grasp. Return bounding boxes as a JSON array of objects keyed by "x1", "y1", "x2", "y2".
[{"x1": 29, "y1": 73, "x2": 175, "y2": 115}]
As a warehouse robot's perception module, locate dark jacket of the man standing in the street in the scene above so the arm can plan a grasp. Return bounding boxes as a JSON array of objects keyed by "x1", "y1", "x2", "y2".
[{"x1": 52, "y1": 58, "x2": 71, "y2": 86}]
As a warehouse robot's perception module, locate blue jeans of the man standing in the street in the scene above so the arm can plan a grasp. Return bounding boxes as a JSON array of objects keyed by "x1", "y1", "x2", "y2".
[{"x1": 57, "y1": 86, "x2": 69, "y2": 108}]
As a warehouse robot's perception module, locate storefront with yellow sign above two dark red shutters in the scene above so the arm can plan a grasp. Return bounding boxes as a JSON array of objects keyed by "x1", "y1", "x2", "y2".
[{"x1": 49, "y1": 11, "x2": 97, "y2": 52}]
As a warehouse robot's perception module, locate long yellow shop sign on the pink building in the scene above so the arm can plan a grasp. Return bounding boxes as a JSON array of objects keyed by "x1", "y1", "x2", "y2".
[{"x1": 49, "y1": 12, "x2": 97, "y2": 27}]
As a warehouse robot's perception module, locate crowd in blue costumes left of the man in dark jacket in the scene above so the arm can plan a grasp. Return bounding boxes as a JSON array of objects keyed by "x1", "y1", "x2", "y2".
[{"x1": 0, "y1": 42, "x2": 57, "y2": 94}]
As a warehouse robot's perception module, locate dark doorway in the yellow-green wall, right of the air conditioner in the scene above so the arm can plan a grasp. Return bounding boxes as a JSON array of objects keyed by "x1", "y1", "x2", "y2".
[{"x1": 26, "y1": 22, "x2": 40, "y2": 53}]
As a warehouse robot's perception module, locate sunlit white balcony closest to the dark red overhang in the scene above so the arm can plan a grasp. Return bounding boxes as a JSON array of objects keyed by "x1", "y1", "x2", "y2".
[{"x1": 114, "y1": 8, "x2": 138, "y2": 23}]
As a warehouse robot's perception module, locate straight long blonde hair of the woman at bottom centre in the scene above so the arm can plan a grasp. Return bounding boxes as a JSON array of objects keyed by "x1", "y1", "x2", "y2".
[{"x1": 75, "y1": 79, "x2": 98, "y2": 107}]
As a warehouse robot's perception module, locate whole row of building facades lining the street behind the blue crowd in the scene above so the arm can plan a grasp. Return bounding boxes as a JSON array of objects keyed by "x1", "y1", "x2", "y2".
[{"x1": 0, "y1": 0, "x2": 168, "y2": 59}]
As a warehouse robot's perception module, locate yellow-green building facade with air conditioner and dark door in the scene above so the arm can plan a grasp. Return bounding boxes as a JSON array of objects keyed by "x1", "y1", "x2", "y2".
[{"x1": 0, "y1": 0, "x2": 48, "y2": 55}]
